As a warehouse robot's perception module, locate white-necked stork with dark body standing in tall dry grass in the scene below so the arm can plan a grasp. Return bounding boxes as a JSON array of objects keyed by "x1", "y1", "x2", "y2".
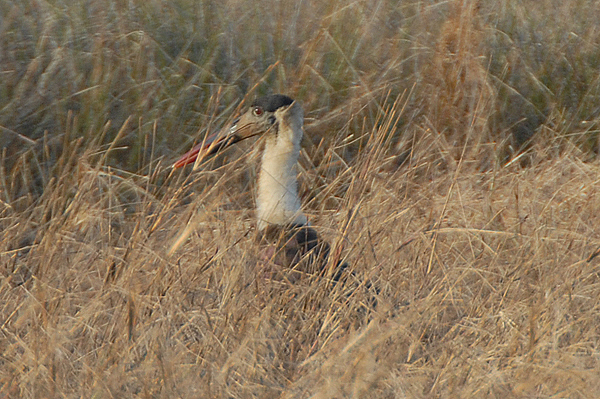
[{"x1": 173, "y1": 94, "x2": 353, "y2": 283}]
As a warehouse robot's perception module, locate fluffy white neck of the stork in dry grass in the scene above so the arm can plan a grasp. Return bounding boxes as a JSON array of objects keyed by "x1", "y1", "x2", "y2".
[{"x1": 256, "y1": 125, "x2": 307, "y2": 230}]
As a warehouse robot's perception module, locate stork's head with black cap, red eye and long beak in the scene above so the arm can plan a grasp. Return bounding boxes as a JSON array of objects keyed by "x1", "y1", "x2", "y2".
[{"x1": 173, "y1": 94, "x2": 304, "y2": 168}]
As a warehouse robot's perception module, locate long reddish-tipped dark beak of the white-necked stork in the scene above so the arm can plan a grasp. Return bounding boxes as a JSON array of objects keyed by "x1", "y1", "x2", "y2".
[{"x1": 173, "y1": 117, "x2": 257, "y2": 168}]
